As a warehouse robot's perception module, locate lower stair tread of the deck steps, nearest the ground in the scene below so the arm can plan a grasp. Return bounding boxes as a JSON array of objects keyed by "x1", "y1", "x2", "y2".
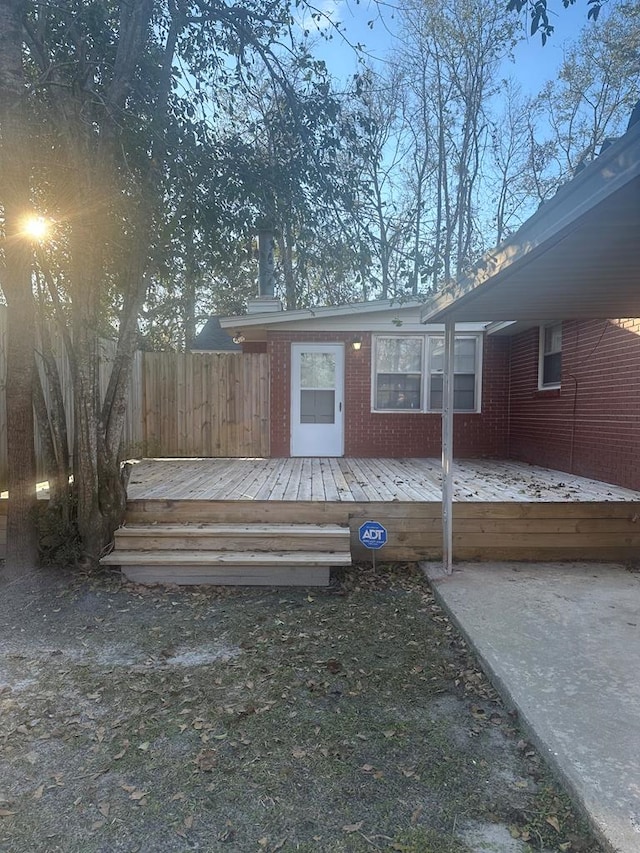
[{"x1": 101, "y1": 549, "x2": 351, "y2": 566}]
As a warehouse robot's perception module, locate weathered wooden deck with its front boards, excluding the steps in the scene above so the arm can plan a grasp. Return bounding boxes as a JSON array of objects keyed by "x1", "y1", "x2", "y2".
[{"x1": 126, "y1": 458, "x2": 640, "y2": 561}]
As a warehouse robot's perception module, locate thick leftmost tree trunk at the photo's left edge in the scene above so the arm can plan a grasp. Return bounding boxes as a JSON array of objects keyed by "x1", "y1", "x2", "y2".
[{"x1": 0, "y1": 0, "x2": 38, "y2": 576}]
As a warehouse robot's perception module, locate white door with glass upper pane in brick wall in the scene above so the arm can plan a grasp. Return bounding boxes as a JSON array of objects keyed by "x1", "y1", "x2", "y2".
[{"x1": 291, "y1": 344, "x2": 344, "y2": 456}]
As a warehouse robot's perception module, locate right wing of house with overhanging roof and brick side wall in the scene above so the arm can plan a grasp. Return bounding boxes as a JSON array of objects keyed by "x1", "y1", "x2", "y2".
[{"x1": 422, "y1": 117, "x2": 640, "y2": 500}]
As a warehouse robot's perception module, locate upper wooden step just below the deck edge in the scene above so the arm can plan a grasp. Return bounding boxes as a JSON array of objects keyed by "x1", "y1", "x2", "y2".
[{"x1": 115, "y1": 523, "x2": 349, "y2": 551}]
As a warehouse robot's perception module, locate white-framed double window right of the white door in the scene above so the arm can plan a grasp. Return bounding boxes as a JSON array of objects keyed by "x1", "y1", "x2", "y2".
[{"x1": 372, "y1": 334, "x2": 482, "y2": 412}]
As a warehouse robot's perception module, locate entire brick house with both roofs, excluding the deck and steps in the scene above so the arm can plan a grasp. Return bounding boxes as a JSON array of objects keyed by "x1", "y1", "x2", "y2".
[{"x1": 221, "y1": 117, "x2": 640, "y2": 496}]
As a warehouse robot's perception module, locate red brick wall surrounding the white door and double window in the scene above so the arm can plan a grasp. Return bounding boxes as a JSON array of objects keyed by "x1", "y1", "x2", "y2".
[{"x1": 268, "y1": 332, "x2": 509, "y2": 458}]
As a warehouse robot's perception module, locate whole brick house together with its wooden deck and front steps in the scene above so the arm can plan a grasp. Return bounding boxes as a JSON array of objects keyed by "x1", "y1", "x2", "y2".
[{"x1": 100, "y1": 116, "x2": 640, "y2": 584}]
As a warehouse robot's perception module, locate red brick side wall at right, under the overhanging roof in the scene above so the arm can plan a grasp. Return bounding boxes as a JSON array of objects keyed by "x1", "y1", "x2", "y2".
[{"x1": 509, "y1": 319, "x2": 640, "y2": 489}]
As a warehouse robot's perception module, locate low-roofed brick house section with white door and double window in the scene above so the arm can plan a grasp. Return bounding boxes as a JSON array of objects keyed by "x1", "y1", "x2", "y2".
[{"x1": 221, "y1": 300, "x2": 508, "y2": 458}]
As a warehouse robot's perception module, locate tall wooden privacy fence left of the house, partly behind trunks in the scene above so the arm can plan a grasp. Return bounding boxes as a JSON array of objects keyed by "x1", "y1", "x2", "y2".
[{"x1": 0, "y1": 306, "x2": 269, "y2": 488}]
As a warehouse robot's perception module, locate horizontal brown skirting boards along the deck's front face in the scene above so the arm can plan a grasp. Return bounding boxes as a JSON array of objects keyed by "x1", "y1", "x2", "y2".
[{"x1": 127, "y1": 500, "x2": 640, "y2": 561}]
